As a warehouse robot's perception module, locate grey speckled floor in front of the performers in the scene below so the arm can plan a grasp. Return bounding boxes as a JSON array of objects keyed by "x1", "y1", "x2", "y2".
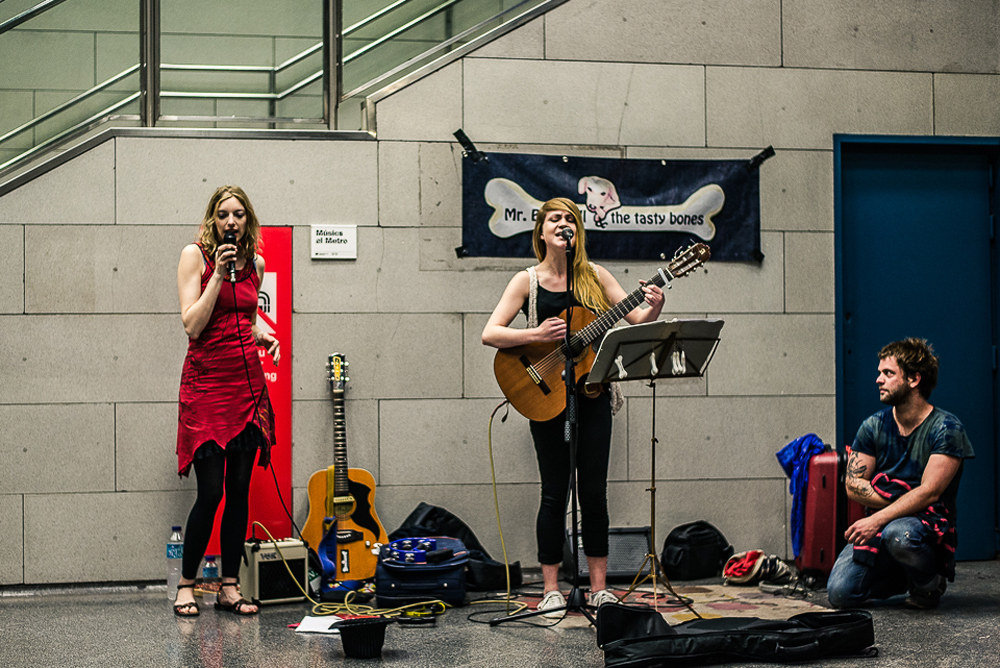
[{"x1": 0, "y1": 561, "x2": 1000, "y2": 668}]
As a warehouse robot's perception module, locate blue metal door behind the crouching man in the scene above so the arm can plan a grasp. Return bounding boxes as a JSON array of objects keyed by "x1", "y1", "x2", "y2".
[{"x1": 835, "y1": 137, "x2": 998, "y2": 560}]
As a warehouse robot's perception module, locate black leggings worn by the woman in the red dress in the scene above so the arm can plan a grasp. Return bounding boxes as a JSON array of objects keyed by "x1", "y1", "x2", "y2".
[{"x1": 181, "y1": 446, "x2": 257, "y2": 580}]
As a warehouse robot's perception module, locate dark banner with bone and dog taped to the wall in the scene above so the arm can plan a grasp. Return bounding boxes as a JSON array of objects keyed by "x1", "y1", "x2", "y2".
[{"x1": 462, "y1": 153, "x2": 763, "y2": 262}]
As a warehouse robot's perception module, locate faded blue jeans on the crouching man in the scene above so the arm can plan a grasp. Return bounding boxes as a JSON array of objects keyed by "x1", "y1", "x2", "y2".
[{"x1": 826, "y1": 517, "x2": 938, "y2": 608}]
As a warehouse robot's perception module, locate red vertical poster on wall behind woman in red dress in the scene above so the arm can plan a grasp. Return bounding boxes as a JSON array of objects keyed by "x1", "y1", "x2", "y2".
[{"x1": 208, "y1": 227, "x2": 292, "y2": 554}]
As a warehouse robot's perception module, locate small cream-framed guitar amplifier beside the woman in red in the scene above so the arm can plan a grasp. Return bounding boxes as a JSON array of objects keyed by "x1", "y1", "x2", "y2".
[{"x1": 240, "y1": 538, "x2": 309, "y2": 605}]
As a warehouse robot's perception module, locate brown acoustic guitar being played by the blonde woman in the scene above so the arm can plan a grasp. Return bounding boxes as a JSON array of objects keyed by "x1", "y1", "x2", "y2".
[{"x1": 493, "y1": 243, "x2": 711, "y2": 422}]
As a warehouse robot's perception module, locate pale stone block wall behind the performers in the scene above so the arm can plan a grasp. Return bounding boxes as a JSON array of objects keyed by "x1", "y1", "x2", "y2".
[{"x1": 0, "y1": 0, "x2": 1000, "y2": 584}]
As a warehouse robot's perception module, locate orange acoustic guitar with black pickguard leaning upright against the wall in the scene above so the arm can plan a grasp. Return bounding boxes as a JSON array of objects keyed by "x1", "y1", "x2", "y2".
[{"x1": 302, "y1": 353, "x2": 389, "y2": 580}]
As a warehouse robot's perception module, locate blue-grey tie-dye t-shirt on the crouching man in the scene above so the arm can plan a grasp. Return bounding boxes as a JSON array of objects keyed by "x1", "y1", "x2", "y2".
[{"x1": 852, "y1": 406, "x2": 976, "y2": 521}]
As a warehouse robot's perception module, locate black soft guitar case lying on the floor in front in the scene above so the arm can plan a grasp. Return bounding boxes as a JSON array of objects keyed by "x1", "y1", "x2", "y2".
[{"x1": 597, "y1": 603, "x2": 878, "y2": 668}]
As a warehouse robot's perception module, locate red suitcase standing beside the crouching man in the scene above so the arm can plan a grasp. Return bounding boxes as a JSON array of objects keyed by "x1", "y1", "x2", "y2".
[{"x1": 795, "y1": 450, "x2": 865, "y2": 576}]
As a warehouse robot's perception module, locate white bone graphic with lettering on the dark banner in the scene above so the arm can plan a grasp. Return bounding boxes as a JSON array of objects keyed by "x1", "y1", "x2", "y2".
[{"x1": 483, "y1": 177, "x2": 726, "y2": 241}]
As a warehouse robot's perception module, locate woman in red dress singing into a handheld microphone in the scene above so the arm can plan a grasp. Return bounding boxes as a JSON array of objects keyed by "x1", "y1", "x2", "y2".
[{"x1": 174, "y1": 186, "x2": 280, "y2": 617}]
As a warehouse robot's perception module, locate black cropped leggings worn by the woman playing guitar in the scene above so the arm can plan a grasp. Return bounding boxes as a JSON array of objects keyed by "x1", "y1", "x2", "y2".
[{"x1": 529, "y1": 391, "x2": 611, "y2": 564}]
